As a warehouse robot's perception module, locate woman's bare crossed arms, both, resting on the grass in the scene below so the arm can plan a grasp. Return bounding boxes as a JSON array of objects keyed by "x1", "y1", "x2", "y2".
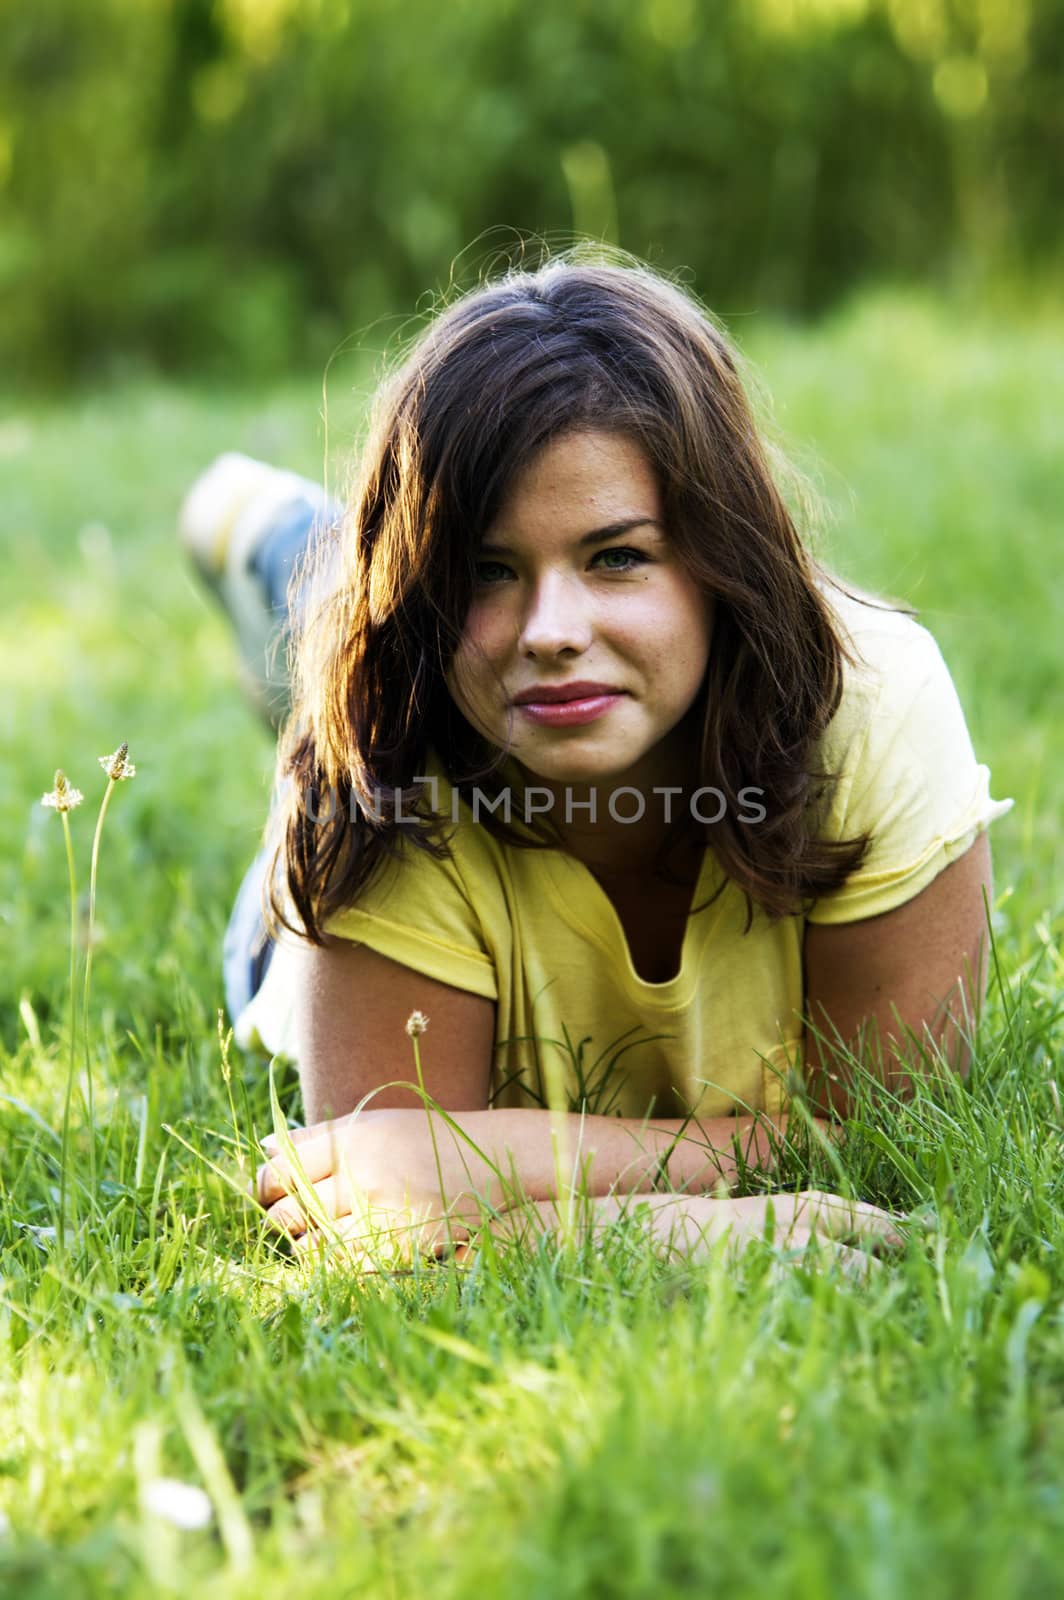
[{"x1": 258, "y1": 834, "x2": 990, "y2": 1237}]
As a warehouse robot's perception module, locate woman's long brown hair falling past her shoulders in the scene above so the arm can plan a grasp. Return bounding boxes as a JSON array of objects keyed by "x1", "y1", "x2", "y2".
[{"x1": 270, "y1": 259, "x2": 867, "y2": 942}]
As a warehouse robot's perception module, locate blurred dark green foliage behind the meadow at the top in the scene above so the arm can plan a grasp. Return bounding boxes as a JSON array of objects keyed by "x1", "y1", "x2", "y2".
[{"x1": 0, "y1": 0, "x2": 1064, "y2": 382}]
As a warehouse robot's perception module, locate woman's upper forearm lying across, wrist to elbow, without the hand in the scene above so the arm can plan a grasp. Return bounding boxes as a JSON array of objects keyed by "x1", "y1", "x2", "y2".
[{"x1": 435, "y1": 1109, "x2": 796, "y2": 1205}]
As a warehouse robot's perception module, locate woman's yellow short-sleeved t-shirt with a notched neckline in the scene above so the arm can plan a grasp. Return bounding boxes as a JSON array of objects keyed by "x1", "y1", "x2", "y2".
[{"x1": 238, "y1": 590, "x2": 1013, "y2": 1117}]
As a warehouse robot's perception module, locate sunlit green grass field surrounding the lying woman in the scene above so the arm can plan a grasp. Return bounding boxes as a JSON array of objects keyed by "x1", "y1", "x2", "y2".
[{"x1": 0, "y1": 296, "x2": 1064, "y2": 1600}]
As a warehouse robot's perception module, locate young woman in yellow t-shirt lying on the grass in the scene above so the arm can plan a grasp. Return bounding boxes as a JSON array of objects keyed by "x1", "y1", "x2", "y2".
[{"x1": 184, "y1": 261, "x2": 1011, "y2": 1250}]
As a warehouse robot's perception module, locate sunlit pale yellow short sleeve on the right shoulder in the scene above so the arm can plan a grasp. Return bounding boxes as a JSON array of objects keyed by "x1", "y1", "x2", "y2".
[{"x1": 808, "y1": 613, "x2": 1013, "y2": 925}]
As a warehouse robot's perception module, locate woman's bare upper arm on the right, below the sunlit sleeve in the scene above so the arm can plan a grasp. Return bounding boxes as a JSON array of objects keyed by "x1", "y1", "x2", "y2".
[{"x1": 805, "y1": 834, "x2": 994, "y2": 1117}]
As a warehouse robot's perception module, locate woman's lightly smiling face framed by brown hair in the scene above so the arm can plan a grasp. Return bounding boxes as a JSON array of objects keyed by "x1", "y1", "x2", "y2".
[{"x1": 448, "y1": 432, "x2": 710, "y2": 784}]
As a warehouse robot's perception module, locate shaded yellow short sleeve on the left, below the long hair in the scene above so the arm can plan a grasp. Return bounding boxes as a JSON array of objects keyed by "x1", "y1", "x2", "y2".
[{"x1": 326, "y1": 829, "x2": 498, "y2": 1000}]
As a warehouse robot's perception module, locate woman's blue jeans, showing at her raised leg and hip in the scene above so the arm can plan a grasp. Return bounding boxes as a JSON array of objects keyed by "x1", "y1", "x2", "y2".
[{"x1": 222, "y1": 480, "x2": 341, "y2": 1022}]
